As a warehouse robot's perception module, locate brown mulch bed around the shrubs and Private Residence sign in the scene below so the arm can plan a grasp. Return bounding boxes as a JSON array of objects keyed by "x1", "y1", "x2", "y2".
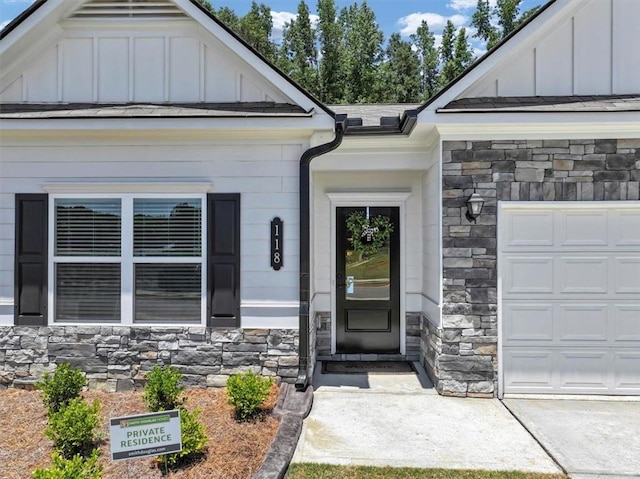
[{"x1": 0, "y1": 386, "x2": 278, "y2": 479}]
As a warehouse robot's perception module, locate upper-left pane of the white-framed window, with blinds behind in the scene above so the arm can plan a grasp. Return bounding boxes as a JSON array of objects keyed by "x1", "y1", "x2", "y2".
[{"x1": 55, "y1": 198, "x2": 122, "y2": 256}]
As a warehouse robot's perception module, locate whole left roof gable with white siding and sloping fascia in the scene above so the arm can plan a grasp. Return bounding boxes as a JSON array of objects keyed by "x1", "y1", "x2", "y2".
[{"x1": 0, "y1": 0, "x2": 331, "y2": 114}]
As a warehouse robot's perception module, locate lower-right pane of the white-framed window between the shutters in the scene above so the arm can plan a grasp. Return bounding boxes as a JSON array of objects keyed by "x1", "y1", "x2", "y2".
[{"x1": 134, "y1": 263, "x2": 202, "y2": 322}]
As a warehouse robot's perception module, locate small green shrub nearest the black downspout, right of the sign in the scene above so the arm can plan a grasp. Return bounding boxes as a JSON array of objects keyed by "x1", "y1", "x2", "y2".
[{"x1": 227, "y1": 371, "x2": 273, "y2": 420}]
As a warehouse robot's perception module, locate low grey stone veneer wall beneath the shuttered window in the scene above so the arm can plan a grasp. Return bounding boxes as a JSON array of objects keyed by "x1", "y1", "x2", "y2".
[{"x1": 0, "y1": 326, "x2": 298, "y2": 391}]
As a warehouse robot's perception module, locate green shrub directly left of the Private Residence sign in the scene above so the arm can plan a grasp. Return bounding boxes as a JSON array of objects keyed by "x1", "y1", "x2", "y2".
[{"x1": 44, "y1": 398, "x2": 100, "y2": 459}]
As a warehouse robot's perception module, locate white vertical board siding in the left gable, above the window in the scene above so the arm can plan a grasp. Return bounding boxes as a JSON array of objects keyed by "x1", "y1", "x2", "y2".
[{"x1": 0, "y1": 27, "x2": 293, "y2": 103}]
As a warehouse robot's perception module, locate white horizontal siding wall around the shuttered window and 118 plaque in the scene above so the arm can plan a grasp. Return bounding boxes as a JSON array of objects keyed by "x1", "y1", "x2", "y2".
[{"x1": 0, "y1": 140, "x2": 308, "y2": 328}]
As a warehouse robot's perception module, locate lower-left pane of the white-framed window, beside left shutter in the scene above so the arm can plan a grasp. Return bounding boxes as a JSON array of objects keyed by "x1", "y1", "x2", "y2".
[{"x1": 55, "y1": 263, "x2": 120, "y2": 322}]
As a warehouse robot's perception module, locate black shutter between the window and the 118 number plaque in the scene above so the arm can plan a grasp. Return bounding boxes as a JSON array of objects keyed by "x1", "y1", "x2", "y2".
[{"x1": 207, "y1": 193, "x2": 240, "y2": 327}]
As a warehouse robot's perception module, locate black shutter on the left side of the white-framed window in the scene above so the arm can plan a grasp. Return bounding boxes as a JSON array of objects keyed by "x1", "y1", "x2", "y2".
[{"x1": 14, "y1": 194, "x2": 48, "y2": 326}]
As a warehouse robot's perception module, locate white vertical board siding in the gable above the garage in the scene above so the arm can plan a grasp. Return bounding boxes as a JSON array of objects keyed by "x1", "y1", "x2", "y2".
[{"x1": 460, "y1": 0, "x2": 640, "y2": 98}]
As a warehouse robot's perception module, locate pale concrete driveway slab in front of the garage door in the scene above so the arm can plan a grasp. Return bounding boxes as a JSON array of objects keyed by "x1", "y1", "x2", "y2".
[{"x1": 503, "y1": 399, "x2": 640, "y2": 479}]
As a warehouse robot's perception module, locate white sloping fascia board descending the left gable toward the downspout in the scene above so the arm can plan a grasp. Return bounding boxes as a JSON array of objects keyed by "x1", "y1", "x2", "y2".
[{"x1": 174, "y1": 0, "x2": 334, "y2": 117}]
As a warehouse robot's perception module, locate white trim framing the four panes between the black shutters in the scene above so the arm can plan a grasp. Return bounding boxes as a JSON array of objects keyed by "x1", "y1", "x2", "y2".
[{"x1": 47, "y1": 193, "x2": 208, "y2": 328}]
